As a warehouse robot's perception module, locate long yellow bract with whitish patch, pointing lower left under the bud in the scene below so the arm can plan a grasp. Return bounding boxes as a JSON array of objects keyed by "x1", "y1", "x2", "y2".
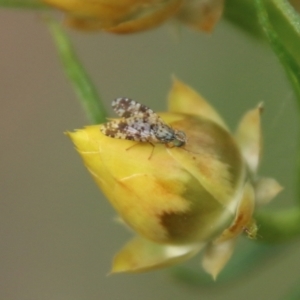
[{"x1": 111, "y1": 237, "x2": 201, "y2": 273}]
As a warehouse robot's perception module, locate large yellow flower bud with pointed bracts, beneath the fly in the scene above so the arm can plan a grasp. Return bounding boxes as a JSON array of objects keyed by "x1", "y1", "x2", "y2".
[{"x1": 68, "y1": 80, "x2": 281, "y2": 278}]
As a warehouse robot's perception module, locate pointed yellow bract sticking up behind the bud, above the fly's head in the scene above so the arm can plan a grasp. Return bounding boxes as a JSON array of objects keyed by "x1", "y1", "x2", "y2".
[{"x1": 168, "y1": 78, "x2": 228, "y2": 130}]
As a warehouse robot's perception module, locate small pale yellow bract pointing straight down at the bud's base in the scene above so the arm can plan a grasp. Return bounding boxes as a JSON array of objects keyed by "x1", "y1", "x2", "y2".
[{"x1": 202, "y1": 240, "x2": 235, "y2": 280}]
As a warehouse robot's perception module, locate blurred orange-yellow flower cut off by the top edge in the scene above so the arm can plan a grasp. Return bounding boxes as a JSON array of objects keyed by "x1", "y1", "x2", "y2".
[{"x1": 42, "y1": 0, "x2": 224, "y2": 33}]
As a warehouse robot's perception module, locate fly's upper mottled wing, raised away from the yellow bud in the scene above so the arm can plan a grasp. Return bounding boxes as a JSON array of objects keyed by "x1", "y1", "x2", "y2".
[{"x1": 111, "y1": 98, "x2": 157, "y2": 118}]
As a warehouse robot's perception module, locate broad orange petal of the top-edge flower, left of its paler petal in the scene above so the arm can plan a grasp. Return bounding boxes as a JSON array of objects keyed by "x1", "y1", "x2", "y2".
[{"x1": 43, "y1": 0, "x2": 183, "y2": 33}]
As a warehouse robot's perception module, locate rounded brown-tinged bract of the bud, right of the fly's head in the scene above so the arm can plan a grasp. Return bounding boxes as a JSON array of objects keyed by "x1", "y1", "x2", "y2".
[{"x1": 171, "y1": 116, "x2": 244, "y2": 204}]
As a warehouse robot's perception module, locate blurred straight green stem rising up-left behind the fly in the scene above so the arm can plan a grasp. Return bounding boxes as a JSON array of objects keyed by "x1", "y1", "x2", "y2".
[{"x1": 48, "y1": 20, "x2": 106, "y2": 124}]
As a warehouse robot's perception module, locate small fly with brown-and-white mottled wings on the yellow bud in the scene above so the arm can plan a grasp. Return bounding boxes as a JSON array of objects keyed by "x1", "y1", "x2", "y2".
[{"x1": 100, "y1": 98, "x2": 187, "y2": 151}]
